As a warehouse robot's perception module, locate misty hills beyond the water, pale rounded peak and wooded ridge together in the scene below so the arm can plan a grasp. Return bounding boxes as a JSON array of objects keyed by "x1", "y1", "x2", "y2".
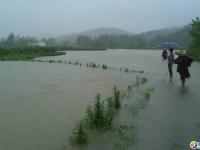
[{"x1": 57, "y1": 25, "x2": 191, "y2": 49}]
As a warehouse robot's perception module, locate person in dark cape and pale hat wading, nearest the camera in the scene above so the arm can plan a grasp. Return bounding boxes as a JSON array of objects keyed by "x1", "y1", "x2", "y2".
[{"x1": 174, "y1": 52, "x2": 193, "y2": 87}]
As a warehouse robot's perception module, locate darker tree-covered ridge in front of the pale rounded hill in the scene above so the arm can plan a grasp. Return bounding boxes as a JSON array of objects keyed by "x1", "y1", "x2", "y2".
[{"x1": 73, "y1": 25, "x2": 191, "y2": 49}]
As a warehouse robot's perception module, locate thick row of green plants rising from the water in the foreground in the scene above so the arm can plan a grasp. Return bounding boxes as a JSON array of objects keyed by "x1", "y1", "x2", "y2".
[{"x1": 71, "y1": 76, "x2": 152, "y2": 147}]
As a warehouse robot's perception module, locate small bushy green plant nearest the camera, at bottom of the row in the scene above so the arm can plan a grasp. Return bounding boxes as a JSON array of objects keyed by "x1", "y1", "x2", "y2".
[{"x1": 71, "y1": 121, "x2": 88, "y2": 144}]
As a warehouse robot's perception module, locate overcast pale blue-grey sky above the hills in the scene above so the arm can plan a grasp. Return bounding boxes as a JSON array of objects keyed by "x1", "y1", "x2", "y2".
[{"x1": 0, "y1": 0, "x2": 200, "y2": 37}]
